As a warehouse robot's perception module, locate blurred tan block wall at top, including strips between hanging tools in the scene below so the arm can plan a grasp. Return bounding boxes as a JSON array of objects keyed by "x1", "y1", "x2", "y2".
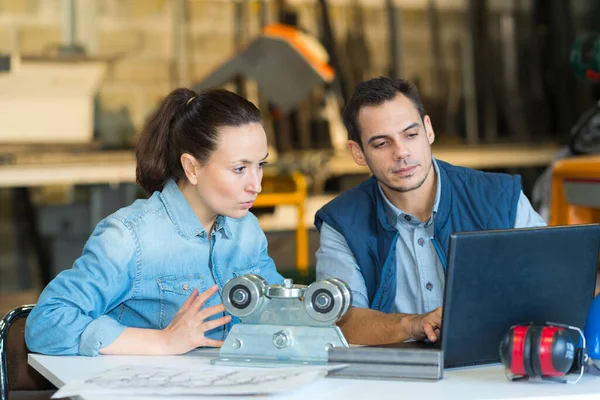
[{"x1": 0, "y1": 0, "x2": 480, "y2": 141}]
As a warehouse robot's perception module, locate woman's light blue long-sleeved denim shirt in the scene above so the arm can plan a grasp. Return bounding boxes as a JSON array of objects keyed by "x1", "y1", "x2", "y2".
[{"x1": 25, "y1": 180, "x2": 283, "y2": 356}]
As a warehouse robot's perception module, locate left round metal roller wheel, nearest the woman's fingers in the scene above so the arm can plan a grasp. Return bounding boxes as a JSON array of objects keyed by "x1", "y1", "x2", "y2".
[{"x1": 222, "y1": 274, "x2": 268, "y2": 317}]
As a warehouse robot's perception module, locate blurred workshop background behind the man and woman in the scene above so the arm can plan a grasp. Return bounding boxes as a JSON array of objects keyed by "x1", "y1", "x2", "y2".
[{"x1": 0, "y1": 0, "x2": 600, "y2": 314}]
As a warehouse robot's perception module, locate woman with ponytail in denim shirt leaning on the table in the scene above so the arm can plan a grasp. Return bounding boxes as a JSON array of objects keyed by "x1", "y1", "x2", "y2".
[{"x1": 25, "y1": 89, "x2": 283, "y2": 356}]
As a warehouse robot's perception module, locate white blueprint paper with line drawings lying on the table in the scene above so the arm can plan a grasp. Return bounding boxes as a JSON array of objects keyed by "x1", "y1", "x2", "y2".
[{"x1": 52, "y1": 365, "x2": 327, "y2": 399}]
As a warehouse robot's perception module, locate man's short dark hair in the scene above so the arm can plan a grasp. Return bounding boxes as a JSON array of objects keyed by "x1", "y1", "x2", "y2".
[{"x1": 343, "y1": 76, "x2": 425, "y2": 147}]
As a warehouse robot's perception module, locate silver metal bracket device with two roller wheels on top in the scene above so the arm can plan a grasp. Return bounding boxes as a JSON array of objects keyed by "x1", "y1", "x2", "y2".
[{"x1": 213, "y1": 274, "x2": 352, "y2": 364}]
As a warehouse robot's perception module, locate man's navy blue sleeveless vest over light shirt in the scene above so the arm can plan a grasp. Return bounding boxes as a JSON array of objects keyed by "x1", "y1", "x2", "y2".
[{"x1": 315, "y1": 160, "x2": 521, "y2": 313}]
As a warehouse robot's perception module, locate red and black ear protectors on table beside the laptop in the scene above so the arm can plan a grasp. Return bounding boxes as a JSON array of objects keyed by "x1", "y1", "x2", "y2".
[{"x1": 500, "y1": 323, "x2": 588, "y2": 383}]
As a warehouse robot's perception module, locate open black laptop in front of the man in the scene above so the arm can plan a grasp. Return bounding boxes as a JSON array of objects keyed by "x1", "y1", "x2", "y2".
[{"x1": 377, "y1": 224, "x2": 600, "y2": 368}]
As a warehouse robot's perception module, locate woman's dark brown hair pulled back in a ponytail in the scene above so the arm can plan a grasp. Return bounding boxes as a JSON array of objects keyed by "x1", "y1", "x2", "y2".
[{"x1": 135, "y1": 89, "x2": 261, "y2": 194}]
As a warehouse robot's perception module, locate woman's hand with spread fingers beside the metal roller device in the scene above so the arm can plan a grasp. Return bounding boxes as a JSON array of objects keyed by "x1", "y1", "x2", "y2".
[{"x1": 162, "y1": 285, "x2": 231, "y2": 354}]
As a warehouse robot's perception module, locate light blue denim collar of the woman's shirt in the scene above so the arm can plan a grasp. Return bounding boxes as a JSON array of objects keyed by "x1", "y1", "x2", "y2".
[{"x1": 160, "y1": 179, "x2": 231, "y2": 239}]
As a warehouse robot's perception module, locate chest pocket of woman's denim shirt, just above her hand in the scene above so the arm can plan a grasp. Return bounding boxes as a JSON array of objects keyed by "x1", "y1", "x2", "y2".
[{"x1": 156, "y1": 274, "x2": 206, "y2": 329}]
